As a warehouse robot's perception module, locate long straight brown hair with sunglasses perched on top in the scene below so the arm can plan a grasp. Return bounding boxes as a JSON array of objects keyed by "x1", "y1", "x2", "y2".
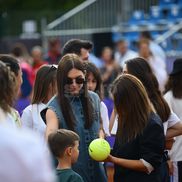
[{"x1": 32, "y1": 65, "x2": 57, "y2": 104}]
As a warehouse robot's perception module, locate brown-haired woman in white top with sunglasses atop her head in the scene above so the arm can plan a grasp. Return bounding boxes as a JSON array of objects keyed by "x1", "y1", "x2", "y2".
[{"x1": 21, "y1": 65, "x2": 57, "y2": 142}]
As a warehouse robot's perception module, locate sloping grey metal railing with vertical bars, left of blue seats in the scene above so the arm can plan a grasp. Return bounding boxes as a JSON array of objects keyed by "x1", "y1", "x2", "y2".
[{"x1": 43, "y1": 0, "x2": 158, "y2": 37}]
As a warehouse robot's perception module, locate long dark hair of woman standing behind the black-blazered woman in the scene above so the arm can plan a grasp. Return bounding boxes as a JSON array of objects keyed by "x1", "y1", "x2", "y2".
[{"x1": 126, "y1": 57, "x2": 170, "y2": 122}]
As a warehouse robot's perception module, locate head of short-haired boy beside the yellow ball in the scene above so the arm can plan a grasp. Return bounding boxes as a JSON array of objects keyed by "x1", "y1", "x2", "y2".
[{"x1": 48, "y1": 129, "x2": 80, "y2": 164}]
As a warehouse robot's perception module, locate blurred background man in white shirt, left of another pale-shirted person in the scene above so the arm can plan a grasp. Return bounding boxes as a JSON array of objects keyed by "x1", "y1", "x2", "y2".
[{"x1": 114, "y1": 39, "x2": 138, "y2": 68}]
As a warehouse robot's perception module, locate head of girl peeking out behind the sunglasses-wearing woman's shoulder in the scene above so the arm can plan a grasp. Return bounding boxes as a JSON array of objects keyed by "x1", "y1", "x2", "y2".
[{"x1": 85, "y1": 62, "x2": 102, "y2": 97}]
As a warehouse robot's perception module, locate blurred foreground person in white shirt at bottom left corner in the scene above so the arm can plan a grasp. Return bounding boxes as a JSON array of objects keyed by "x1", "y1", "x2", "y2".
[{"x1": 0, "y1": 61, "x2": 55, "y2": 182}]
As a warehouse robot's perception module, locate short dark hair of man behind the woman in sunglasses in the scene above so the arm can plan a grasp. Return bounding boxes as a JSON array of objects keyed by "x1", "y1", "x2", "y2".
[{"x1": 62, "y1": 39, "x2": 93, "y2": 56}]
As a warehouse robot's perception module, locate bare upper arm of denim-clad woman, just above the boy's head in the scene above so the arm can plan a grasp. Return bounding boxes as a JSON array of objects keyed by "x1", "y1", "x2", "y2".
[{"x1": 45, "y1": 109, "x2": 59, "y2": 139}]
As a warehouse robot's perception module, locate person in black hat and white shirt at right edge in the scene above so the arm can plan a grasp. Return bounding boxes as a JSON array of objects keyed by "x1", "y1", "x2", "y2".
[{"x1": 164, "y1": 59, "x2": 182, "y2": 182}]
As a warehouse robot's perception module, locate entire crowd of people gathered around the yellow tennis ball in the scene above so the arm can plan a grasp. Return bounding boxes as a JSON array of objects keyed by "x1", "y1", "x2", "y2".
[{"x1": 0, "y1": 32, "x2": 182, "y2": 182}]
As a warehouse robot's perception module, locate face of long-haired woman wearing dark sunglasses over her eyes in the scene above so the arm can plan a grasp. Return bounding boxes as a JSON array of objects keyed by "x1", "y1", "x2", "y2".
[{"x1": 66, "y1": 68, "x2": 85, "y2": 95}]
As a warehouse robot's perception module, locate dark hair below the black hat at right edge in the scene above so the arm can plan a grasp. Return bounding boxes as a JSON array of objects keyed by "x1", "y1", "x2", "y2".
[{"x1": 165, "y1": 72, "x2": 182, "y2": 99}]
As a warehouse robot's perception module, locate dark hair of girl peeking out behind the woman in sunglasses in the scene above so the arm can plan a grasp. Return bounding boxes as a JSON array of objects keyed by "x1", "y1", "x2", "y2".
[{"x1": 84, "y1": 61, "x2": 103, "y2": 100}]
